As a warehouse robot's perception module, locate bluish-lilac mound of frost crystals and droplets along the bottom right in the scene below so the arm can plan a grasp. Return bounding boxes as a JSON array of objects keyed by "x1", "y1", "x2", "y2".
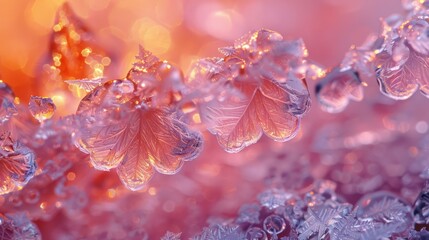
[{"x1": 189, "y1": 182, "x2": 414, "y2": 240}]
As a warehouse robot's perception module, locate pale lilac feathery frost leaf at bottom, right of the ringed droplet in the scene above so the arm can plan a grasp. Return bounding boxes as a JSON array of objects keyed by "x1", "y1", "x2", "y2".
[{"x1": 298, "y1": 206, "x2": 350, "y2": 240}]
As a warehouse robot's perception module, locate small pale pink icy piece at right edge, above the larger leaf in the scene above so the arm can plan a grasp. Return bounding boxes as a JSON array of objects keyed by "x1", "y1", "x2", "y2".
[{"x1": 401, "y1": 18, "x2": 429, "y2": 56}]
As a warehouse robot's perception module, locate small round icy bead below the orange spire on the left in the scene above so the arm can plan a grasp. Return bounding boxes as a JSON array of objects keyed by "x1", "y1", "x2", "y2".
[{"x1": 28, "y1": 96, "x2": 56, "y2": 122}]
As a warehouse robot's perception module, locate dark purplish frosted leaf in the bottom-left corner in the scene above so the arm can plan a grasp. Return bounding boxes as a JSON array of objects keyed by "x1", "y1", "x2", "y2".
[{"x1": 0, "y1": 214, "x2": 42, "y2": 240}]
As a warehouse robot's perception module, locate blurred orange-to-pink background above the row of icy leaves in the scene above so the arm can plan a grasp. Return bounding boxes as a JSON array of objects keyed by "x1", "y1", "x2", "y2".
[{"x1": 0, "y1": 0, "x2": 401, "y2": 100}]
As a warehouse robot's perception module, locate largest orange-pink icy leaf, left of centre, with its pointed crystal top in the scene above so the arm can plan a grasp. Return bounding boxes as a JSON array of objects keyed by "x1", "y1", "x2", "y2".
[{"x1": 76, "y1": 48, "x2": 202, "y2": 190}]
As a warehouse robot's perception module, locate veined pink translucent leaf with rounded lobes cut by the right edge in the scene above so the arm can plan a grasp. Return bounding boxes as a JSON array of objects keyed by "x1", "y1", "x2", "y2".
[{"x1": 376, "y1": 43, "x2": 429, "y2": 99}]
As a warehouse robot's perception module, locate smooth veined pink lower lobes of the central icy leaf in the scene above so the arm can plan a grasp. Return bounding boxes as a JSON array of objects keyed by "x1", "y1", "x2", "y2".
[{"x1": 203, "y1": 80, "x2": 302, "y2": 152}]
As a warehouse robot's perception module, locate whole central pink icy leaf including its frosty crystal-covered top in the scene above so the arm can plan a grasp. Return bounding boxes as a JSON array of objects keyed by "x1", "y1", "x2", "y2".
[{"x1": 188, "y1": 30, "x2": 310, "y2": 152}]
